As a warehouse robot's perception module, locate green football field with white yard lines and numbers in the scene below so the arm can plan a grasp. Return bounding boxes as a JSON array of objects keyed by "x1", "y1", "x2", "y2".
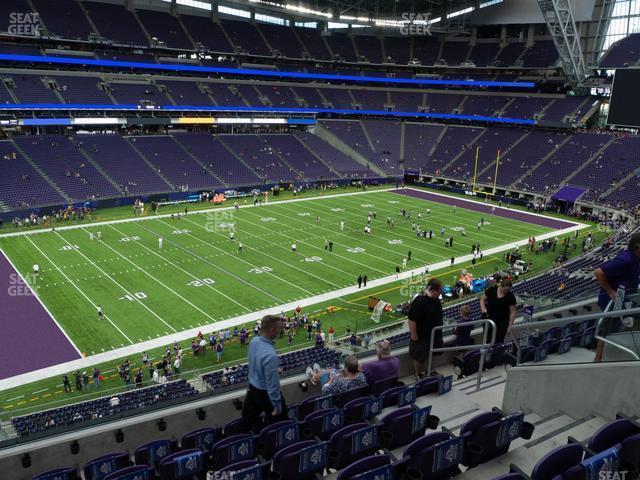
[{"x1": 0, "y1": 191, "x2": 571, "y2": 355}]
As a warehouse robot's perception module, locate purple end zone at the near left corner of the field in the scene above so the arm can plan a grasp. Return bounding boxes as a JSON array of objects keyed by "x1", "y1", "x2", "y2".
[{"x1": 0, "y1": 252, "x2": 80, "y2": 379}]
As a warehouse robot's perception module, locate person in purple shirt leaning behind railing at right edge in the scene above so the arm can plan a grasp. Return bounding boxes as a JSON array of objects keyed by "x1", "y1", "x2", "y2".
[{"x1": 594, "y1": 232, "x2": 640, "y2": 362}]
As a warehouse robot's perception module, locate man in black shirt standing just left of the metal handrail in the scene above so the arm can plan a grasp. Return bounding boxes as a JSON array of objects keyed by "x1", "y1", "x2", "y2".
[{"x1": 408, "y1": 278, "x2": 442, "y2": 378}]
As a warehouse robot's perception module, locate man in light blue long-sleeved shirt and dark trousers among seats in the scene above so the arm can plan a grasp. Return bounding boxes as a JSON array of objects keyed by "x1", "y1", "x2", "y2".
[{"x1": 238, "y1": 315, "x2": 287, "y2": 433}]
